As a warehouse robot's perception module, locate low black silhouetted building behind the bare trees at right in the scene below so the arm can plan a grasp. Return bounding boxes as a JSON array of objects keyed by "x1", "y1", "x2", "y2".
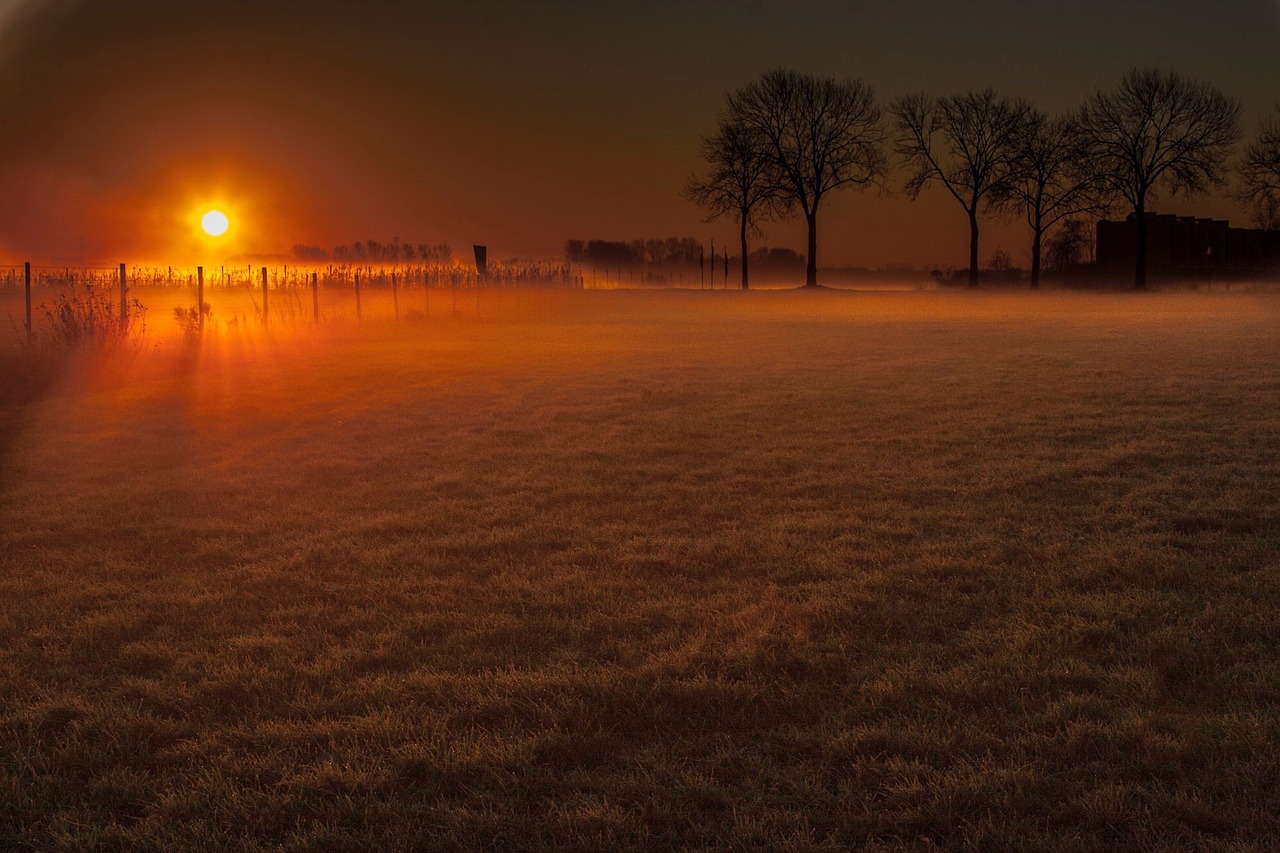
[{"x1": 1096, "y1": 213, "x2": 1280, "y2": 278}]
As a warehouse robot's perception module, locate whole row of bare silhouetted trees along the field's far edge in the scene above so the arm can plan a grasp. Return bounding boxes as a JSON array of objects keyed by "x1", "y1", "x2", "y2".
[{"x1": 685, "y1": 68, "x2": 1280, "y2": 288}]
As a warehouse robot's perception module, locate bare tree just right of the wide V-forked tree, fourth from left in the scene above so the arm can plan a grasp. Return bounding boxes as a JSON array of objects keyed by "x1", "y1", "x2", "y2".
[{"x1": 1001, "y1": 110, "x2": 1108, "y2": 288}]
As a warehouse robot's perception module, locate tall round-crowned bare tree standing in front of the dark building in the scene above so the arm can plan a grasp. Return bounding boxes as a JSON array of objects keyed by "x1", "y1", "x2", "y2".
[{"x1": 1080, "y1": 68, "x2": 1240, "y2": 289}]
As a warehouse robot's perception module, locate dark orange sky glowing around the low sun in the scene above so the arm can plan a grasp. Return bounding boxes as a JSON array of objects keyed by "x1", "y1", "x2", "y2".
[{"x1": 0, "y1": 0, "x2": 1280, "y2": 268}]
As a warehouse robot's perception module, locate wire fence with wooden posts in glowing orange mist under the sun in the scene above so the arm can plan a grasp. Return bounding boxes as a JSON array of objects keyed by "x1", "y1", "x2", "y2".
[{"x1": 0, "y1": 260, "x2": 727, "y2": 347}]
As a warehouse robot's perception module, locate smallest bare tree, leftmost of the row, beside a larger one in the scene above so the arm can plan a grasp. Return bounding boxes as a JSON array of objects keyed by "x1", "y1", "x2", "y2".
[{"x1": 685, "y1": 118, "x2": 787, "y2": 291}]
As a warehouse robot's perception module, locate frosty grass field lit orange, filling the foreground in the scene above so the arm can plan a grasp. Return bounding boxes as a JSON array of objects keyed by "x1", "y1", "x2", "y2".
[{"x1": 0, "y1": 285, "x2": 1280, "y2": 850}]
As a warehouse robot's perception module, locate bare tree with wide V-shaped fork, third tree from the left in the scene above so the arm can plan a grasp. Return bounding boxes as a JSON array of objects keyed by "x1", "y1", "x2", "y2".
[{"x1": 890, "y1": 88, "x2": 1032, "y2": 287}]
